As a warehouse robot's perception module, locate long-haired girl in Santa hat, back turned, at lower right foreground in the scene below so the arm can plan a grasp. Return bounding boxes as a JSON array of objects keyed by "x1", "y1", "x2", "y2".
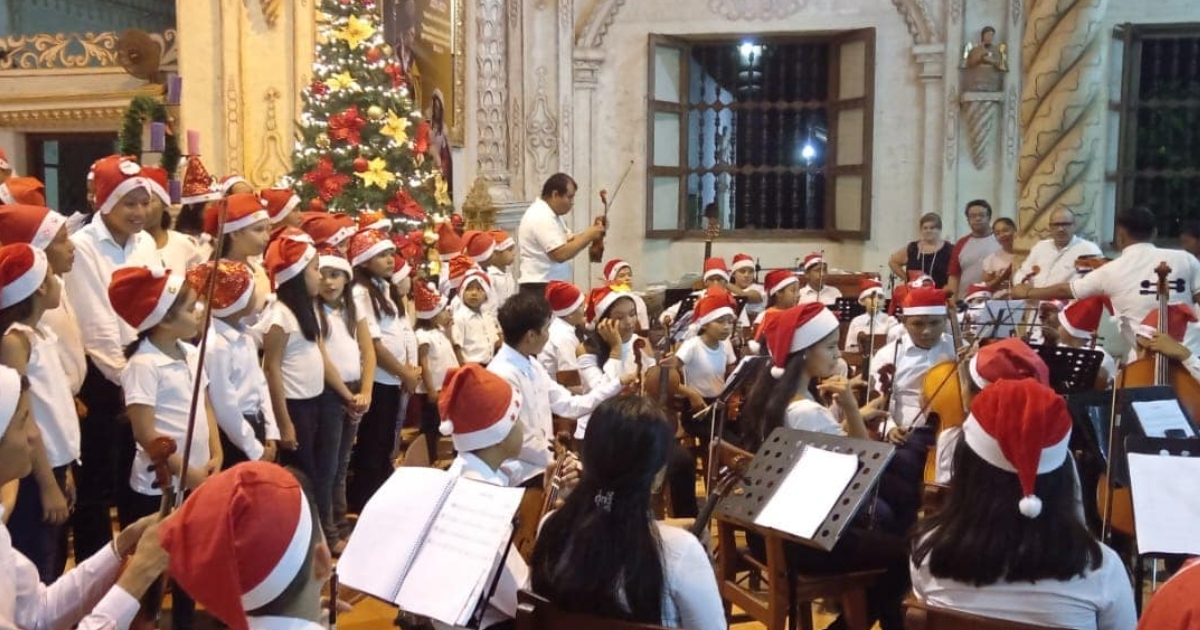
[{"x1": 912, "y1": 379, "x2": 1138, "y2": 630}]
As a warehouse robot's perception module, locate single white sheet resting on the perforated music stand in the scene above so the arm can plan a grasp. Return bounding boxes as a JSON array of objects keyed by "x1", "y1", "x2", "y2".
[{"x1": 755, "y1": 446, "x2": 858, "y2": 539}]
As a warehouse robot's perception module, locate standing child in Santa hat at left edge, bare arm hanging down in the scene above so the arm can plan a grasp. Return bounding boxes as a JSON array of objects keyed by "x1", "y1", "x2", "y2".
[{"x1": 0, "y1": 244, "x2": 79, "y2": 583}]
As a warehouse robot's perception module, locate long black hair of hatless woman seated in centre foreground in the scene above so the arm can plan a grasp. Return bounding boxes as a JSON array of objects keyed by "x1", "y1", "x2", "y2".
[{"x1": 529, "y1": 396, "x2": 674, "y2": 624}]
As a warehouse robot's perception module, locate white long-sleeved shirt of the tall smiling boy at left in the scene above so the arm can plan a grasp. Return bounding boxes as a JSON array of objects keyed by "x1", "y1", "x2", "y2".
[{"x1": 62, "y1": 217, "x2": 158, "y2": 385}]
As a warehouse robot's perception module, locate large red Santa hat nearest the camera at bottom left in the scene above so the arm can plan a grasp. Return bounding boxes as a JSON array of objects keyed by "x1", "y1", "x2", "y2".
[{"x1": 158, "y1": 462, "x2": 316, "y2": 630}]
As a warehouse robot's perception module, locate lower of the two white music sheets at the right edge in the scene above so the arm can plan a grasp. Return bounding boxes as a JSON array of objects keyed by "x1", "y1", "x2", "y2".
[{"x1": 1129, "y1": 452, "x2": 1200, "y2": 554}]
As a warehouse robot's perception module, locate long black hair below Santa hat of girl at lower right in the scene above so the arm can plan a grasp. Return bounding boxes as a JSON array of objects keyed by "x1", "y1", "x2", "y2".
[{"x1": 912, "y1": 436, "x2": 1103, "y2": 587}]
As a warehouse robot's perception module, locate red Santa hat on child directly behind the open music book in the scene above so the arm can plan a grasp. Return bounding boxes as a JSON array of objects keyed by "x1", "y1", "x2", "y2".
[{"x1": 438, "y1": 364, "x2": 521, "y2": 452}]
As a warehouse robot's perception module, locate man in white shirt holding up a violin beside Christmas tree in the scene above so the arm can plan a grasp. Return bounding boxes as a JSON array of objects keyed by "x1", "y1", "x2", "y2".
[{"x1": 517, "y1": 173, "x2": 605, "y2": 295}]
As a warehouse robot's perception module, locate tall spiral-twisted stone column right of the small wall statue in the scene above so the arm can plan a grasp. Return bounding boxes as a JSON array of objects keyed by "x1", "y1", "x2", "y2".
[{"x1": 1016, "y1": 0, "x2": 1108, "y2": 248}]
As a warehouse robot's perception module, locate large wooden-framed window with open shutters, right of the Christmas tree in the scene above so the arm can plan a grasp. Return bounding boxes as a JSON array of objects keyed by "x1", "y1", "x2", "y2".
[{"x1": 646, "y1": 29, "x2": 875, "y2": 240}]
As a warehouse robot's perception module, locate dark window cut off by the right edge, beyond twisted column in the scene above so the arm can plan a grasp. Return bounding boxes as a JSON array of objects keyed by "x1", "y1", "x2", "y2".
[{"x1": 1108, "y1": 24, "x2": 1200, "y2": 240}]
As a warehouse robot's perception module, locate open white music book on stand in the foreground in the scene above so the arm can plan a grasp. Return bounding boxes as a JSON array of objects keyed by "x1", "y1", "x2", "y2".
[{"x1": 337, "y1": 468, "x2": 523, "y2": 625}]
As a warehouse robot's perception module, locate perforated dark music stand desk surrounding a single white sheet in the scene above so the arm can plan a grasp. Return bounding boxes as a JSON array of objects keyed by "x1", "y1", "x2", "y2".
[{"x1": 718, "y1": 427, "x2": 895, "y2": 551}]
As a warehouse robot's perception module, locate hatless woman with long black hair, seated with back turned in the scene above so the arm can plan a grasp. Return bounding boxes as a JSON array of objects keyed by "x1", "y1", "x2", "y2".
[{"x1": 530, "y1": 396, "x2": 727, "y2": 630}]
